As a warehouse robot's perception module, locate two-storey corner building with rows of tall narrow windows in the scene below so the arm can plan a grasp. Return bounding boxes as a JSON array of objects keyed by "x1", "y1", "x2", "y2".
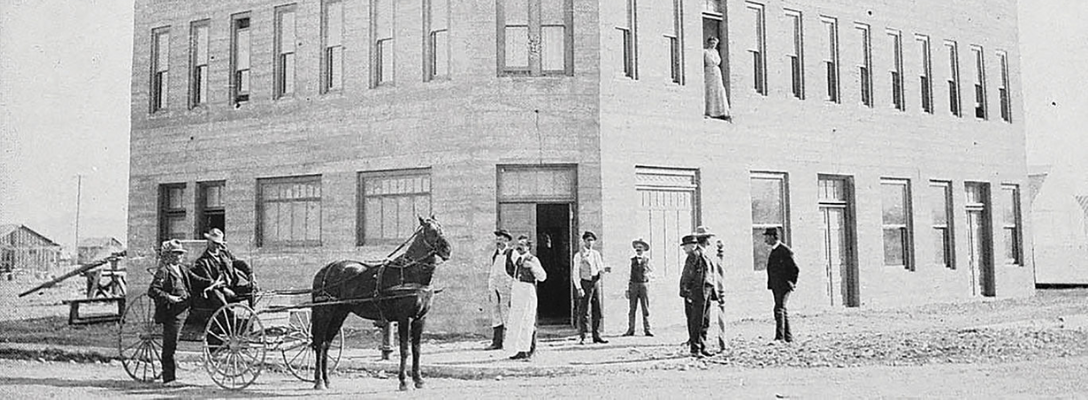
[{"x1": 128, "y1": 0, "x2": 1033, "y2": 332}]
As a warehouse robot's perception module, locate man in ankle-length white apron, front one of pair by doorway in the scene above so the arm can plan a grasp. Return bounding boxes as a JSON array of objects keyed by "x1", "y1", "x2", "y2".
[{"x1": 508, "y1": 235, "x2": 547, "y2": 361}]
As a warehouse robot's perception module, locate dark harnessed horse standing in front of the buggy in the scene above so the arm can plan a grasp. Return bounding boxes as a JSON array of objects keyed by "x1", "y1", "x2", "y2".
[{"x1": 311, "y1": 216, "x2": 450, "y2": 390}]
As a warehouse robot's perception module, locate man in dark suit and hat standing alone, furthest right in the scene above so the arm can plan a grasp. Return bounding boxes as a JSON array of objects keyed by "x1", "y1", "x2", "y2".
[{"x1": 763, "y1": 228, "x2": 799, "y2": 342}]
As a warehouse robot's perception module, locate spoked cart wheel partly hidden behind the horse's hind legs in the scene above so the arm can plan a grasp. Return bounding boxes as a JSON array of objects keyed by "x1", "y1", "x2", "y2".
[{"x1": 280, "y1": 310, "x2": 344, "y2": 382}]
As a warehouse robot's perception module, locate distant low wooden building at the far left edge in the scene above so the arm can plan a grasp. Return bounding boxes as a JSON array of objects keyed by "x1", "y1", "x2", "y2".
[{"x1": 0, "y1": 225, "x2": 61, "y2": 275}]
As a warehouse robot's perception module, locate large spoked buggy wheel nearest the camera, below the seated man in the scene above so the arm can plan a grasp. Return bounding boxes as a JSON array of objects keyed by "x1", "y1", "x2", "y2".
[{"x1": 203, "y1": 303, "x2": 267, "y2": 390}]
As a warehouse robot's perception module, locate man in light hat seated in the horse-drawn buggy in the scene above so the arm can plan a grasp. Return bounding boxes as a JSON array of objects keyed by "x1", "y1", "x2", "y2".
[{"x1": 193, "y1": 228, "x2": 254, "y2": 309}]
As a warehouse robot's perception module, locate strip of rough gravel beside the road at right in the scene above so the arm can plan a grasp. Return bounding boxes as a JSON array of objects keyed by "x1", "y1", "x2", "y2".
[{"x1": 703, "y1": 327, "x2": 1088, "y2": 367}]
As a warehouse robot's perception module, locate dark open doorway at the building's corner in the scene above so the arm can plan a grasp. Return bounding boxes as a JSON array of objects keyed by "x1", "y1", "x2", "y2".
[{"x1": 535, "y1": 204, "x2": 572, "y2": 325}]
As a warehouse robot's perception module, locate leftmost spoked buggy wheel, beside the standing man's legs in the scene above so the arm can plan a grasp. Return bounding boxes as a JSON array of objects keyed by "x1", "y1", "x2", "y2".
[{"x1": 118, "y1": 293, "x2": 162, "y2": 382}]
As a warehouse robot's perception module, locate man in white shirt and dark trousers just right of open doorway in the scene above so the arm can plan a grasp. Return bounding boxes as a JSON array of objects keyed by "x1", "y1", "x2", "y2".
[{"x1": 570, "y1": 230, "x2": 611, "y2": 345}]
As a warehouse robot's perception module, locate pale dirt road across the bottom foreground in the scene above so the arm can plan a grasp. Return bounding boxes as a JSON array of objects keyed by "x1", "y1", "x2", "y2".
[{"x1": 0, "y1": 358, "x2": 1088, "y2": 399}]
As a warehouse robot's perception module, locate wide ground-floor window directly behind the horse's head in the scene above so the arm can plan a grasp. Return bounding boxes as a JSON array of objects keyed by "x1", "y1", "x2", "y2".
[{"x1": 356, "y1": 170, "x2": 431, "y2": 246}]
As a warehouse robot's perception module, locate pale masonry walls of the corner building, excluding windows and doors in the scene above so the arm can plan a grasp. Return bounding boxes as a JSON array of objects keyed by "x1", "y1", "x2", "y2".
[{"x1": 128, "y1": 0, "x2": 1034, "y2": 333}]
